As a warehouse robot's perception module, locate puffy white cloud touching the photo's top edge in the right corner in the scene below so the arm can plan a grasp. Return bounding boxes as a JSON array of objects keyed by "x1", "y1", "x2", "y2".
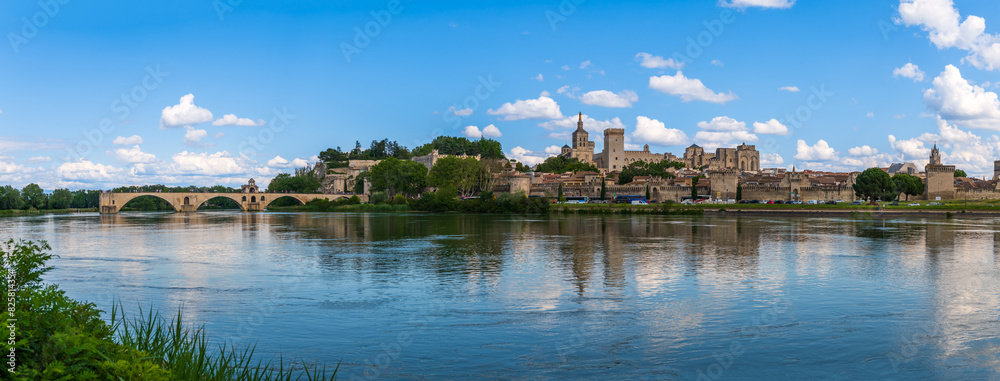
[{"x1": 896, "y1": 0, "x2": 1000, "y2": 70}]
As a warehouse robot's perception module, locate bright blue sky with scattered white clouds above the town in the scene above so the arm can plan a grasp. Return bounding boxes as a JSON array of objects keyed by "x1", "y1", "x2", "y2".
[{"x1": 0, "y1": 0, "x2": 1000, "y2": 189}]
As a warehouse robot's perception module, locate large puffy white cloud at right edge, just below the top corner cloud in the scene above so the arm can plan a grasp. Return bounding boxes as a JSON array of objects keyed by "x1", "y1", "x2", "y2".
[{"x1": 924, "y1": 65, "x2": 1000, "y2": 130}]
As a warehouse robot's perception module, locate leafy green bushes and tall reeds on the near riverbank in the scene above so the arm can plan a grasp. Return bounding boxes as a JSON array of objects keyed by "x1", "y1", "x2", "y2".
[{"x1": 0, "y1": 240, "x2": 336, "y2": 380}]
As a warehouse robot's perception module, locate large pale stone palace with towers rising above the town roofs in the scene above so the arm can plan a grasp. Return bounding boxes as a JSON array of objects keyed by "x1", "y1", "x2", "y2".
[{"x1": 560, "y1": 113, "x2": 760, "y2": 172}]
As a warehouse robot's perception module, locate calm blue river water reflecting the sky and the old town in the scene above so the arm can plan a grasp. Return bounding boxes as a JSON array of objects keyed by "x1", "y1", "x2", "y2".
[{"x1": 0, "y1": 212, "x2": 1000, "y2": 380}]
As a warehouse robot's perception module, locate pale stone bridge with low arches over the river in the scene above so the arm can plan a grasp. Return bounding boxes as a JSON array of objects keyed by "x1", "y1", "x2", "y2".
[{"x1": 99, "y1": 192, "x2": 367, "y2": 214}]
